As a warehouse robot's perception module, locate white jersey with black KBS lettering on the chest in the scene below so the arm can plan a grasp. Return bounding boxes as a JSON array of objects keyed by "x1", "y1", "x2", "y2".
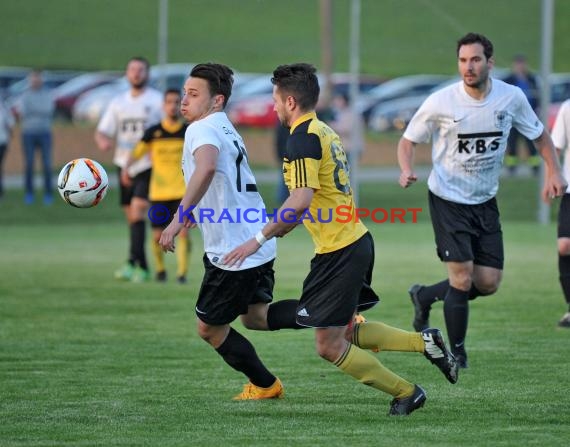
[{"x1": 404, "y1": 79, "x2": 544, "y2": 205}]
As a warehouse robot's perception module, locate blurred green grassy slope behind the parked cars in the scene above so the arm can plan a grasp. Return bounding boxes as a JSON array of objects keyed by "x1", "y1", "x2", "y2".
[{"x1": 0, "y1": 0, "x2": 570, "y2": 77}]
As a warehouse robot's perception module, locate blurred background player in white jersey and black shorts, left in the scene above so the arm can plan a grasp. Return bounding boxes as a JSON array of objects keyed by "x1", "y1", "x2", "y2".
[{"x1": 95, "y1": 57, "x2": 162, "y2": 282}]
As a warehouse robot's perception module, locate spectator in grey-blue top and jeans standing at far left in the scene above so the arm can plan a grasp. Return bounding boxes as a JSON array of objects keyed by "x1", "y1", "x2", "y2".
[{"x1": 16, "y1": 70, "x2": 55, "y2": 205}]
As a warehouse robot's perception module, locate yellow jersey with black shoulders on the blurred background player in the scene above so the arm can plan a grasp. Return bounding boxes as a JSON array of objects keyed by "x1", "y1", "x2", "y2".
[{"x1": 133, "y1": 120, "x2": 187, "y2": 202}]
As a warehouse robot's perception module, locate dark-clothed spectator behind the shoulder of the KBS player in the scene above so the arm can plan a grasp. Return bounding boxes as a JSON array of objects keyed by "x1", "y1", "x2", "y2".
[{"x1": 505, "y1": 54, "x2": 540, "y2": 175}]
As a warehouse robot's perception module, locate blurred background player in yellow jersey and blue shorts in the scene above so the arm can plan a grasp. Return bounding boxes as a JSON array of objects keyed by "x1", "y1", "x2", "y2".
[{"x1": 121, "y1": 89, "x2": 190, "y2": 284}]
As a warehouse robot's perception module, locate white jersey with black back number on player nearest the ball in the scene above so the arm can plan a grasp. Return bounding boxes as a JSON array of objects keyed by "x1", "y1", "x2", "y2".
[{"x1": 182, "y1": 112, "x2": 276, "y2": 270}]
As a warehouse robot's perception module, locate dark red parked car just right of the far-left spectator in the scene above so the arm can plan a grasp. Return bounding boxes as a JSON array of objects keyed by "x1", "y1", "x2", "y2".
[{"x1": 53, "y1": 72, "x2": 120, "y2": 120}]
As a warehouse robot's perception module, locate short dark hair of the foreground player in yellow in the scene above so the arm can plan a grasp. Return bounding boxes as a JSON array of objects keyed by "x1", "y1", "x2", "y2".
[{"x1": 271, "y1": 63, "x2": 321, "y2": 111}]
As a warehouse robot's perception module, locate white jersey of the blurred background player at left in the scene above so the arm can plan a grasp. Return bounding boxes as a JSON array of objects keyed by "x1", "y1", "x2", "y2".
[{"x1": 97, "y1": 87, "x2": 162, "y2": 176}]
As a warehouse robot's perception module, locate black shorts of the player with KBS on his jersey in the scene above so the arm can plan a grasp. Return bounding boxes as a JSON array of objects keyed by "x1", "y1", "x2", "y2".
[{"x1": 429, "y1": 191, "x2": 505, "y2": 270}]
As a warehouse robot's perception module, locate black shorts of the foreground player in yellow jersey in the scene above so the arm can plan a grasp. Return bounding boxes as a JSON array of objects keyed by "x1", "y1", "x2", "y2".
[{"x1": 297, "y1": 233, "x2": 379, "y2": 328}]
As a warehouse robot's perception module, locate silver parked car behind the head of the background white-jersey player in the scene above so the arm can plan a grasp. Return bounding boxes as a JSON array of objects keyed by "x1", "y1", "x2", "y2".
[{"x1": 72, "y1": 64, "x2": 193, "y2": 123}]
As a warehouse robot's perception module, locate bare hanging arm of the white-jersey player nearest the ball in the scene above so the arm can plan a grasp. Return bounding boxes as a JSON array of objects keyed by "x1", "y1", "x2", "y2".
[{"x1": 158, "y1": 144, "x2": 218, "y2": 251}]
